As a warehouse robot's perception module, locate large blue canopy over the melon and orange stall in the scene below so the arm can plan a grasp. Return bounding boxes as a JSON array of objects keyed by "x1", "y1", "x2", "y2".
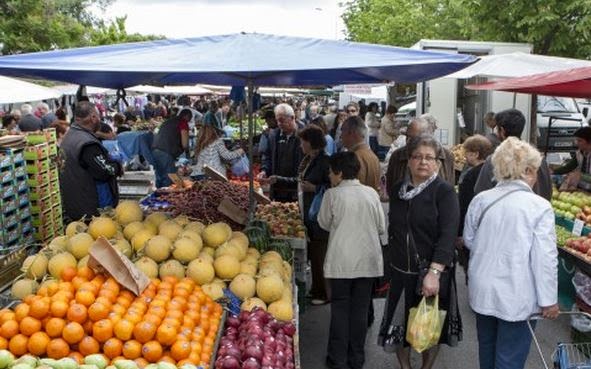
[{"x1": 0, "y1": 33, "x2": 477, "y2": 89}]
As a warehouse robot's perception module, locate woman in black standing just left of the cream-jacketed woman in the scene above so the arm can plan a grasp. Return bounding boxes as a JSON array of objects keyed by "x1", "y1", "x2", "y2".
[{"x1": 298, "y1": 126, "x2": 330, "y2": 305}]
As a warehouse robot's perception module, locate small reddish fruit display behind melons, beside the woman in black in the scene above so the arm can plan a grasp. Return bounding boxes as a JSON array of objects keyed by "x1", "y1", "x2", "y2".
[{"x1": 256, "y1": 202, "x2": 306, "y2": 238}]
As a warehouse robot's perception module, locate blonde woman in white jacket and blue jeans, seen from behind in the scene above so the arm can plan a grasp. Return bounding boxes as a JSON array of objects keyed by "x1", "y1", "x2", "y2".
[{"x1": 464, "y1": 137, "x2": 558, "y2": 369}]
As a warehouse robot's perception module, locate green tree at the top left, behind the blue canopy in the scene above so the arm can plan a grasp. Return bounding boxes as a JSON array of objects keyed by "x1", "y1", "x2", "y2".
[{"x1": 0, "y1": 0, "x2": 162, "y2": 54}]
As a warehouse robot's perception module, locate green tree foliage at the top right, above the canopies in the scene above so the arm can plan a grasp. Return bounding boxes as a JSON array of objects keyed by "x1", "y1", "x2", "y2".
[{"x1": 343, "y1": 0, "x2": 591, "y2": 58}]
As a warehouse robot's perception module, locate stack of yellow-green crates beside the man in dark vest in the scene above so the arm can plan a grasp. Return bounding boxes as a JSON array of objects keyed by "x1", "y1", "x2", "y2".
[{"x1": 24, "y1": 128, "x2": 64, "y2": 242}]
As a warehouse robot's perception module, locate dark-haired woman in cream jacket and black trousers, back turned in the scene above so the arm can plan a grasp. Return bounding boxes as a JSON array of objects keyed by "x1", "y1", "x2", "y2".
[{"x1": 318, "y1": 152, "x2": 386, "y2": 369}]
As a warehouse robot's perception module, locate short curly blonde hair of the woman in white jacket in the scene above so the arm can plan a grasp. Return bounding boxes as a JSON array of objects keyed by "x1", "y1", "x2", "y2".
[{"x1": 492, "y1": 137, "x2": 542, "y2": 182}]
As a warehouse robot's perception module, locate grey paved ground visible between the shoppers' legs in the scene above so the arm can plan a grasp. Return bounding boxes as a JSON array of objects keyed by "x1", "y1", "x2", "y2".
[{"x1": 300, "y1": 268, "x2": 571, "y2": 369}]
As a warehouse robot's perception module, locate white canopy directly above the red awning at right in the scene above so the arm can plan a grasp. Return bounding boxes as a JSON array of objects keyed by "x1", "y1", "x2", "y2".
[{"x1": 445, "y1": 52, "x2": 591, "y2": 79}]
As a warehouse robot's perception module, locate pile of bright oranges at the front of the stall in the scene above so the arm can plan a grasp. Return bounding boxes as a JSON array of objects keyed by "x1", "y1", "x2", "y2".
[{"x1": 0, "y1": 267, "x2": 222, "y2": 368}]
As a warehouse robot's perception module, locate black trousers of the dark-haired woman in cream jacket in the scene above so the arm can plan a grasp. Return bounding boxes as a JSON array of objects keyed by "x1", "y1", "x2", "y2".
[{"x1": 326, "y1": 278, "x2": 375, "y2": 369}]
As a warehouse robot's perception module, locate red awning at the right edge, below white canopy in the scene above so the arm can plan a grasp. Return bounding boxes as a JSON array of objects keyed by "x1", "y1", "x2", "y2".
[{"x1": 466, "y1": 67, "x2": 591, "y2": 98}]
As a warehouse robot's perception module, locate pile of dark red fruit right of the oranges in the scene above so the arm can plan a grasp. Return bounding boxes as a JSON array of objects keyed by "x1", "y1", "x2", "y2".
[{"x1": 215, "y1": 308, "x2": 296, "y2": 369}]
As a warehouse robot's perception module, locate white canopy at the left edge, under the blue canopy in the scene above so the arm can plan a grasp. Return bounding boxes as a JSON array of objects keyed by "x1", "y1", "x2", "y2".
[{"x1": 0, "y1": 76, "x2": 62, "y2": 104}]
